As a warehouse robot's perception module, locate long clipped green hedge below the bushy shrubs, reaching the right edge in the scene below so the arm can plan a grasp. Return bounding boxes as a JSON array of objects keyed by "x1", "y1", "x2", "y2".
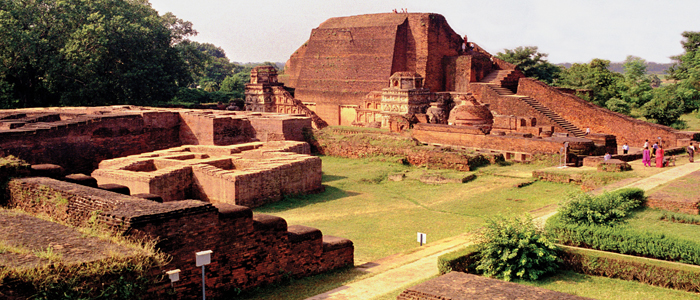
[{"x1": 546, "y1": 215, "x2": 700, "y2": 265}]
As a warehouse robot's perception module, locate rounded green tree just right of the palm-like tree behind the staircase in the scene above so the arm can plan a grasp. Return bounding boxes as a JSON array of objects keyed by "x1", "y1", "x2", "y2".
[{"x1": 554, "y1": 58, "x2": 623, "y2": 107}]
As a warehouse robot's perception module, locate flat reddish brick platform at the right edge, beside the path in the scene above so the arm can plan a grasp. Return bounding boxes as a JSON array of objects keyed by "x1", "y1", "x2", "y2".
[{"x1": 646, "y1": 171, "x2": 700, "y2": 214}]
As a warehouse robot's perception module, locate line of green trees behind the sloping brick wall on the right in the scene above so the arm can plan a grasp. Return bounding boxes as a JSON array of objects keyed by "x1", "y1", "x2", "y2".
[{"x1": 496, "y1": 31, "x2": 700, "y2": 128}]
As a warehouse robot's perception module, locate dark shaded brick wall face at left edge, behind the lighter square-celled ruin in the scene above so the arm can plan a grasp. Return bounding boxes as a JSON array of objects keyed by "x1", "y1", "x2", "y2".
[{"x1": 0, "y1": 112, "x2": 180, "y2": 173}]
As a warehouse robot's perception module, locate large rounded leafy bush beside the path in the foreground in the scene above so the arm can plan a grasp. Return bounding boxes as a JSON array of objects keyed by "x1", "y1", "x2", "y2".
[{"x1": 476, "y1": 215, "x2": 558, "y2": 281}]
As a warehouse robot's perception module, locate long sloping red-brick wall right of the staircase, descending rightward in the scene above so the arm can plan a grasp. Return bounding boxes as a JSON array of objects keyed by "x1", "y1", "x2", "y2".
[{"x1": 518, "y1": 78, "x2": 677, "y2": 147}]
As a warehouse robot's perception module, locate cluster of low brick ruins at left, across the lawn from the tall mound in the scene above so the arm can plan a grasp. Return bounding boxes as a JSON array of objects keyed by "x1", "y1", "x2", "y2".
[{"x1": 0, "y1": 106, "x2": 354, "y2": 298}]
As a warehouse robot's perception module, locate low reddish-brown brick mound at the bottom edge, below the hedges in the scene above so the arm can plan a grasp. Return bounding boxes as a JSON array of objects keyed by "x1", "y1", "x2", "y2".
[{"x1": 396, "y1": 272, "x2": 590, "y2": 300}]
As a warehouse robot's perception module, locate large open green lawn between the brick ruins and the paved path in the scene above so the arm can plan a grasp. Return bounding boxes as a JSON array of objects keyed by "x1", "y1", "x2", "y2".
[{"x1": 255, "y1": 157, "x2": 580, "y2": 264}]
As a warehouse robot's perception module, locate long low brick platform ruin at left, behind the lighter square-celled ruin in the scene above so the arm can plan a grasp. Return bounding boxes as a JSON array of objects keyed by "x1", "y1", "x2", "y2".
[{"x1": 0, "y1": 106, "x2": 311, "y2": 174}]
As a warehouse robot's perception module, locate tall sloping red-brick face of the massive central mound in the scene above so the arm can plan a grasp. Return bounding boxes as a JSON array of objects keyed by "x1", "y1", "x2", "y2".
[{"x1": 285, "y1": 13, "x2": 462, "y2": 125}]
